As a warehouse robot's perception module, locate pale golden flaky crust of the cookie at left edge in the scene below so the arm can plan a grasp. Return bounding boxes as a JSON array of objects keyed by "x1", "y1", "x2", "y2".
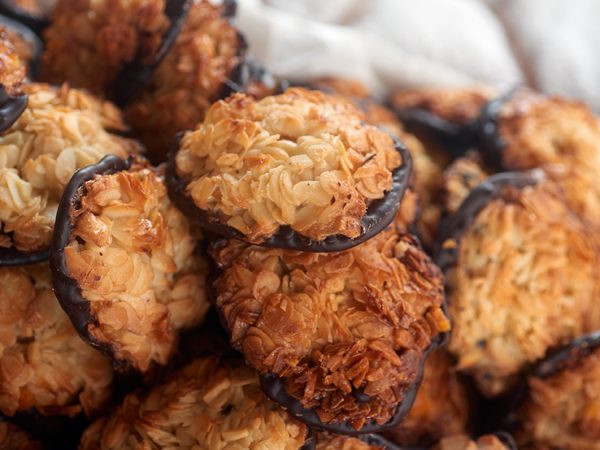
[{"x1": 0, "y1": 84, "x2": 139, "y2": 251}]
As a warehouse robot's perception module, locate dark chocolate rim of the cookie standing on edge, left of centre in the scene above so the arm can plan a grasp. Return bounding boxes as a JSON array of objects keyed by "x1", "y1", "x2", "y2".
[{"x1": 50, "y1": 155, "x2": 131, "y2": 366}]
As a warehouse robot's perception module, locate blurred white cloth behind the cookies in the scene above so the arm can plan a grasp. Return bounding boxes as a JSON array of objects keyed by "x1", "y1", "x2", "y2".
[{"x1": 238, "y1": 0, "x2": 600, "y2": 111}]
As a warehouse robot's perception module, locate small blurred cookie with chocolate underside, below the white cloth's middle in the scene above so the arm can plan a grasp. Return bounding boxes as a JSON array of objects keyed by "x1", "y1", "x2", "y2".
[{"x1": 389, "y1": 87, "x2": 494, "y2": 156}]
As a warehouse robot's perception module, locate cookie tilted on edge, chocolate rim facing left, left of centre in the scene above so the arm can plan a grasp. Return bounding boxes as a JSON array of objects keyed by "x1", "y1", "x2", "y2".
[{"x1": 50, "y1": 156, "x2": 208, "y2": 371}]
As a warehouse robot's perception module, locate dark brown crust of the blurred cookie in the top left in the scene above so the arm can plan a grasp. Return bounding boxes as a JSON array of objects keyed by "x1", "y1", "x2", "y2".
[{"x1": 42, "y1": 0, "x2": 169, "y2": 94}]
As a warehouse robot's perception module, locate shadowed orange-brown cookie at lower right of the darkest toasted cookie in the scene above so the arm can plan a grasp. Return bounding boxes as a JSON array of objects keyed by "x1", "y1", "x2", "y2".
[{"x1": 385, "y1": 349, "x2": 474, "y2": 446}]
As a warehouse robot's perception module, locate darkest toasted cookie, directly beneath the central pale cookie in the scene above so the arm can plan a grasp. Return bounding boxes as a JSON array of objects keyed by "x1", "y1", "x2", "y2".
[{"x1": 212, "y1": 230, "x2": 449, "y2": 433}]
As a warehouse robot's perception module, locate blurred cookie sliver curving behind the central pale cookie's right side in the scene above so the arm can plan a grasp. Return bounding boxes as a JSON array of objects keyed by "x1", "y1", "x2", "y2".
[{"x1": 306, "y1": 78, "x2": 442, "y2": 247}]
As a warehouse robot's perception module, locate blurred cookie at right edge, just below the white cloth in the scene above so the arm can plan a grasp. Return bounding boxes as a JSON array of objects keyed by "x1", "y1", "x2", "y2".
[{"x1": 482, "y1": 90, "x2": 600, "y2": 229}]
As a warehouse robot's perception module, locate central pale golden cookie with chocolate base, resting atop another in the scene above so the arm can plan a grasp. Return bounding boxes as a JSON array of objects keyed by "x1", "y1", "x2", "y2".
[{"x1": 167, "y1": 88, "x2": 411, "y2": 251}]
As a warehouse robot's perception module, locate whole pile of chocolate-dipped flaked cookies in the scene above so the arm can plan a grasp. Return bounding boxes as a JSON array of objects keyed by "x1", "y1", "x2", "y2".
[{"x1": 0, "y1": 0, "x2": 600, "y2": 450}]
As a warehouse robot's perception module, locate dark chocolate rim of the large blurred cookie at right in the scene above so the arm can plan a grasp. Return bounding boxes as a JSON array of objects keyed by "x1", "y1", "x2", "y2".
[{"x1": 435, "y1": 169, "x2": 544, "y2": 272}]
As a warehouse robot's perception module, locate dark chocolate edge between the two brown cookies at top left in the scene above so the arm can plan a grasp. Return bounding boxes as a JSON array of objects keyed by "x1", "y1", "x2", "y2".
[{"x1": 112, "y1": 0, "x2": 193, "y2": 106}]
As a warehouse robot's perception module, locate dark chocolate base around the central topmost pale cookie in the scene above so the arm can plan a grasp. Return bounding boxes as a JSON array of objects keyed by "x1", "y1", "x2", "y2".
[{"x1": 165, "y1": 134, "x2": 412, "y2": 253}]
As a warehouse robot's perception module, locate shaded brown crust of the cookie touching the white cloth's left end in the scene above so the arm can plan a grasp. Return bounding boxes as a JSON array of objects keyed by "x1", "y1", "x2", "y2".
[{"x1": 125, "y1": 0, "x2": 245, "y2": 161}]
